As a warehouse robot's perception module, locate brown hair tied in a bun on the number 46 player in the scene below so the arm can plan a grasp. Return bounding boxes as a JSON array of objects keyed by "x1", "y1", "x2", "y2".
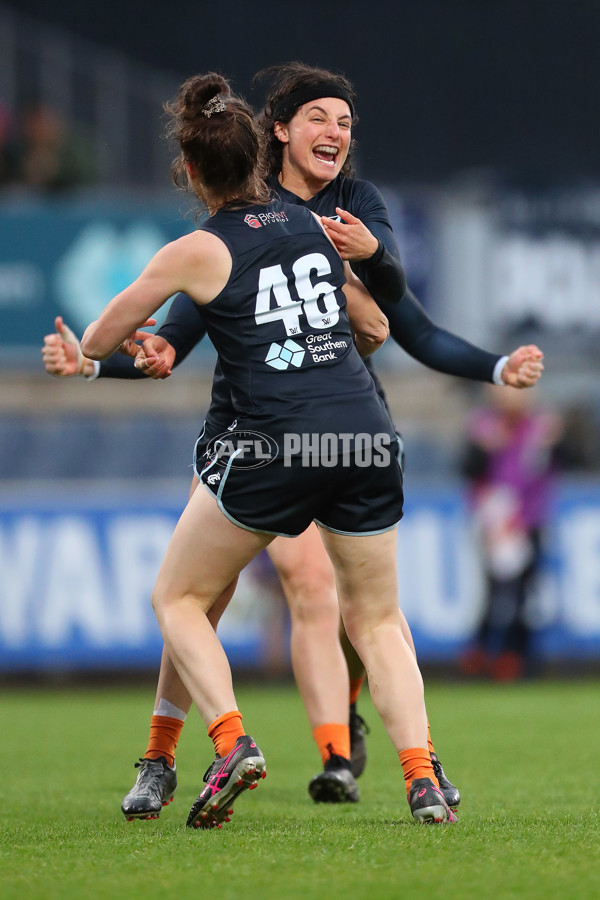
[{"x1": 165, "y1": 72, "x2": 269, "y2": 205}]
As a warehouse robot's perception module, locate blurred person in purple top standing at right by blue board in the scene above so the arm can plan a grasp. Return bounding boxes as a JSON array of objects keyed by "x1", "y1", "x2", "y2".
[{"x1": 461, "y1": 386, "x2": 565, "y2": 681}]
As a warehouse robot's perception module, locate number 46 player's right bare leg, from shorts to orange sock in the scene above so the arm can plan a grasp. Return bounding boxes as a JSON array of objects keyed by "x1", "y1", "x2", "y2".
[{"x1": 322, "y1": 529, "x2": 427, "y2": 751}]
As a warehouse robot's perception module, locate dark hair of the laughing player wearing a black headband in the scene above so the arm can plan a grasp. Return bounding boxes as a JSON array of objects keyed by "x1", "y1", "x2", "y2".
[{"x1": 252, "y1": 62, "x2": 358, "y2": 177}]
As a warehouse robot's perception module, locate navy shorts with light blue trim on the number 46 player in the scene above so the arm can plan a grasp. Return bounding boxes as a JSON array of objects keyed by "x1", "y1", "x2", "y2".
[{"x1": 195, "y1": 433, "x2": 404, "y2": 537}]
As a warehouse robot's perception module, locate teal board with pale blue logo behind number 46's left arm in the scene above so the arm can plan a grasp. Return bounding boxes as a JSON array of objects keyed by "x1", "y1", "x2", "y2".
[{"x1": 0, "y1": 197, "x2": 206, "y2": 362}]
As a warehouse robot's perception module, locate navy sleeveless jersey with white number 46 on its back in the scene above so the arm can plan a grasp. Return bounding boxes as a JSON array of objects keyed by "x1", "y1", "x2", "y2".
[{"x1": 196, "y1": 199, "x2": 395, "y2": 458}]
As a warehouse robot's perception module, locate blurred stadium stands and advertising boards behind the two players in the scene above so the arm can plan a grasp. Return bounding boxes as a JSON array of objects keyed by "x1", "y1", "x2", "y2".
[{"x1": 0, "y1": 0, "x2": 600, "y2": 677}]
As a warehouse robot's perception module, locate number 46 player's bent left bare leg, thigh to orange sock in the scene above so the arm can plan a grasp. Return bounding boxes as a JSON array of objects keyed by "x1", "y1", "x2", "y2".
[{"x1": 152, "y1": 490, "x2": 272, "y2": 726}]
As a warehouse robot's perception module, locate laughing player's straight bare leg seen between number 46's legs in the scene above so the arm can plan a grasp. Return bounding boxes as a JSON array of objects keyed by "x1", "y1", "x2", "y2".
[{"x1": 268, "y1": 525, "x2": 349, "y2": 729}]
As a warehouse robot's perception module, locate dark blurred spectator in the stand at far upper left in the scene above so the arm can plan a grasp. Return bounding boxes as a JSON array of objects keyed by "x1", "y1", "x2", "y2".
[{"x1": 2, "y1": 102, "x2": 96, "y2": 192}]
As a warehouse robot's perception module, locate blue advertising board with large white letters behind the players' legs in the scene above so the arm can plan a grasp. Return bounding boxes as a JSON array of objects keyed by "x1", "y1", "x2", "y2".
[{"x1": 0, "y1": 481, "x2": 600, "y2": 672}]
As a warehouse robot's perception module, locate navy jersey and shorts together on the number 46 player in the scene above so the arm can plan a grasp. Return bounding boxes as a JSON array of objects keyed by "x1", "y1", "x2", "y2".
[{"x1": 196, "y1": 200, "x2": 403, "y2": 536}]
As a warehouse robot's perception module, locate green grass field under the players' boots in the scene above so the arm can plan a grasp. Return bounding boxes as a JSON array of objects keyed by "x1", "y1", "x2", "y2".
[{"x1": 0, "y1": 682, "x2": 600, "y2": 900}]
